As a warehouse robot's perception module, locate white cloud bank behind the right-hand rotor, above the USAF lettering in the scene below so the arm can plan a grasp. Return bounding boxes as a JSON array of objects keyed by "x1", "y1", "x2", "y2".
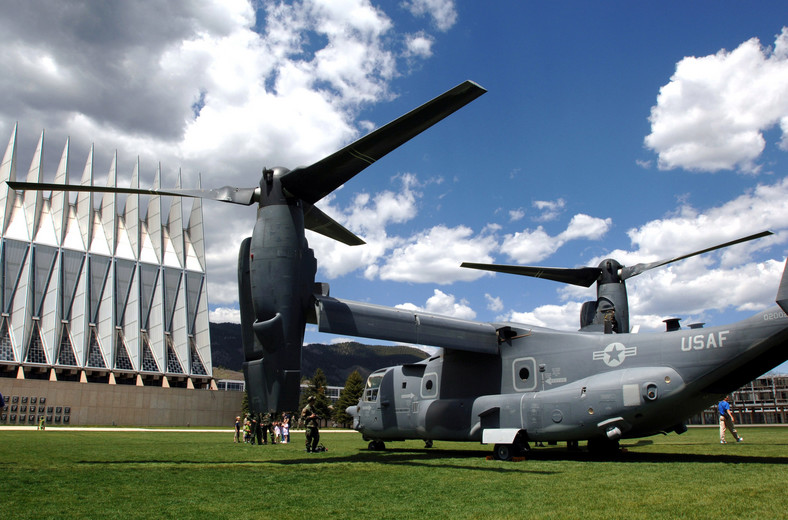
[{"x1": 498, "y1": 177, "x2": 788, "y2": 330}]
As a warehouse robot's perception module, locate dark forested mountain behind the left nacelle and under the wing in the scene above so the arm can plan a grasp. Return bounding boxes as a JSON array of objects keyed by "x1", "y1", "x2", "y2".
[{"x1": 210, "y1": 323, "x2": 428, "y2": 386}]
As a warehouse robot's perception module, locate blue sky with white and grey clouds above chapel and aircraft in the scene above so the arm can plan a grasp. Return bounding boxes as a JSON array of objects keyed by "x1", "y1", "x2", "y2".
[{"x1": 0, "y1": 0, "x2": 788, "y2": 372}]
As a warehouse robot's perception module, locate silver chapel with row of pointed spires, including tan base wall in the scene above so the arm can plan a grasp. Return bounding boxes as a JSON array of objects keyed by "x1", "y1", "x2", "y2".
[{"x1": 0, "y1": 127, "x2": 240, "y2": 425}]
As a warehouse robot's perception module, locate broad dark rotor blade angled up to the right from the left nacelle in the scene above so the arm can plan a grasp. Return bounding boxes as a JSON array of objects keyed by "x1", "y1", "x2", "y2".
[{"x1": 281, "y1": 81, "x2": 487, "y2": 204}]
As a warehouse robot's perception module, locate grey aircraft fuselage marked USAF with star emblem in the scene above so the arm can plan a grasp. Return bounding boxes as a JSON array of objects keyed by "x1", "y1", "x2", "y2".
[{"x1": 351, "y1": 307, "x2": 788, "y2": 442}]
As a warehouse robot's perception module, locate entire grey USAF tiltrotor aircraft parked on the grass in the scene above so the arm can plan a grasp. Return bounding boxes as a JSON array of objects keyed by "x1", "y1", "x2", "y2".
[{"x1": 9, "y1": 81, "x2": 788, "y2": 459}]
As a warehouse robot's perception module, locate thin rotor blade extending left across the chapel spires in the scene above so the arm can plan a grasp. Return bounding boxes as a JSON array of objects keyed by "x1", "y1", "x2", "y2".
[{"x1": 6, "y1": 181, "x2": 256, "y2": 206}]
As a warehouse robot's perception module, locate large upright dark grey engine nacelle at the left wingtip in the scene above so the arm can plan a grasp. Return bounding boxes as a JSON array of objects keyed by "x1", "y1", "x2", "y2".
[{"x1": 238, "y1": 189, "x2": 317, "y2": 412}]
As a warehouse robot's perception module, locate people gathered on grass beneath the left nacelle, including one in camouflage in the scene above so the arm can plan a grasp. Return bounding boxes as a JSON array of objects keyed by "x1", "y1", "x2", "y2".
[{"x1": 233, "y1": 396, "x2": 325, "y2": 453}]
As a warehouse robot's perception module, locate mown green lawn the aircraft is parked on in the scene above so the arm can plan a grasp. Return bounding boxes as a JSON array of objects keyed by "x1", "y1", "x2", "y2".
[{"x1": 0, "y1": 427, "x2": 788, "y2": 520}]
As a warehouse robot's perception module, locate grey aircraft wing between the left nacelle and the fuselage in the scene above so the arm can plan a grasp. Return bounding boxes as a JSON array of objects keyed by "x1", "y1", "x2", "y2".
[{"x1": 315, "y1": 294, "x2": 499, "y2": 355}]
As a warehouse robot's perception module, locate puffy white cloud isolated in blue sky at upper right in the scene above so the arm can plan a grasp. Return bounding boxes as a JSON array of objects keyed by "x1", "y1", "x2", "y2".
[{"x1": 645, "y1": 28, "x2": 788, "y2": 173}]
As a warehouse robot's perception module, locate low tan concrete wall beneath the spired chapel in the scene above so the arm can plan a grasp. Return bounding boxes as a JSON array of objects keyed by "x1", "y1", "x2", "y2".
[{"x1": 0, "y1": 378, "x2": 243, "y2": 428}]
